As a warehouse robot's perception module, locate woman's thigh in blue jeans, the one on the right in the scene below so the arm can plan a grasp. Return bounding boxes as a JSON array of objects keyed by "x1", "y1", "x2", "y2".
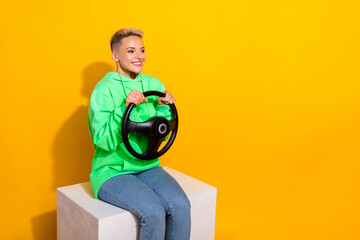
[{"x1": 135, "y1": 167, "x2": 190, "y2": 212}]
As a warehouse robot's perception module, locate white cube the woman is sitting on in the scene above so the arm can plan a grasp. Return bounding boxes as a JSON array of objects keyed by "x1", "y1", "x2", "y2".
[{"x1": 57, "y1": 167, "x2": 217, "y2": 240}]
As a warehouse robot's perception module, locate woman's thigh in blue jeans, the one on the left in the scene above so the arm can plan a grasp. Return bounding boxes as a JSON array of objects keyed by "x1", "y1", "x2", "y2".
[{"x1": 98, "y1": 174, "x2": 164, "y2": 219}]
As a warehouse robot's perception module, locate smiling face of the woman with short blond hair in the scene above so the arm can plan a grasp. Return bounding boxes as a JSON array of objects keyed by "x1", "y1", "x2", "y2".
[{"x1": 111, "y1": 36, "x2": 146, "y2": 79}]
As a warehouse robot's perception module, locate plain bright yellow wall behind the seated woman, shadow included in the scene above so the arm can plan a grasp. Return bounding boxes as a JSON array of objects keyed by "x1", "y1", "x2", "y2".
[{"x1": 0, "y1": 0, "x2": 360, "y2": 240}]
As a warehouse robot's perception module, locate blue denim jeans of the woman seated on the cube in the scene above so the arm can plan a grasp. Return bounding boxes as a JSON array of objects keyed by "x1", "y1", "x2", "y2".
[{"x1": 98, "y1": 167, "x2": 191, "y2": 240}]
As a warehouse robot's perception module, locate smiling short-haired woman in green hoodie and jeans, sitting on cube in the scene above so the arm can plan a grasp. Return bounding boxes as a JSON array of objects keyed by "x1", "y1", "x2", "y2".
[{"x1": 89, "y1": 28, "x2": 190, "y2": 240}]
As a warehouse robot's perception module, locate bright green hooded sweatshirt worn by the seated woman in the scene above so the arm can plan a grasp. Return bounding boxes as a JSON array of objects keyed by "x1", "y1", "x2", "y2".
[{"x1": 88, "y1": 72, "x2": 171, "y2": 198}]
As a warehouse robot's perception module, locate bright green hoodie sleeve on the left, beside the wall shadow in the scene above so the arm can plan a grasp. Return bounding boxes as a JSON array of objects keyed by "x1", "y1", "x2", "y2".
[{"x1": 89, "y1": 89, "x2": 126, "y2": 151}]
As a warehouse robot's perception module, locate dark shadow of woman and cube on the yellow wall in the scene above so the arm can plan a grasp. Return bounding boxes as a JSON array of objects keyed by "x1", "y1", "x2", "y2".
[{"x1": 31, "y1": 62, "x2": 113, "y2": 240}]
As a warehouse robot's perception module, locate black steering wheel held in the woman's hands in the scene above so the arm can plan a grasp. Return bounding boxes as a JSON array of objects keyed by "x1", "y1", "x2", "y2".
[{"x1": 121, "y1": 91, "x2": 179, "y2": 160}]
